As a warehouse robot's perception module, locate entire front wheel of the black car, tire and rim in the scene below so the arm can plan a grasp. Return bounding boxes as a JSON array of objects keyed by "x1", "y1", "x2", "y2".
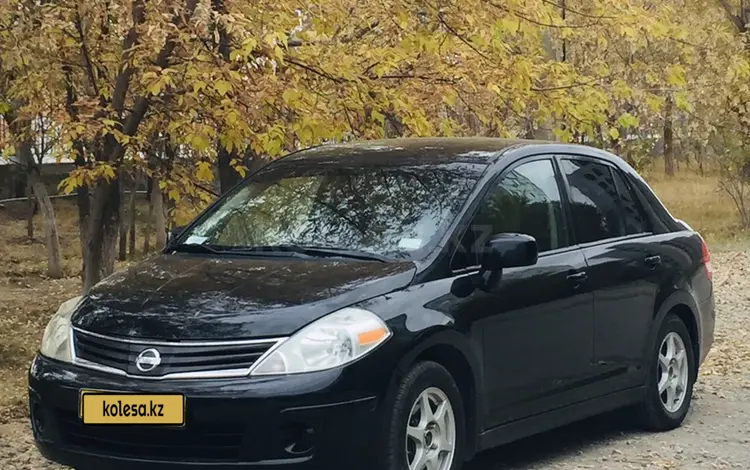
[{"x1": 378, "y1": 361, "x2": 466, "y2": 470}]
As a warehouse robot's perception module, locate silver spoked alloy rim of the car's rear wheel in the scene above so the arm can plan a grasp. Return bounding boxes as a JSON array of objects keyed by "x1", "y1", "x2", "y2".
[{"x1": 660, "y1": 331, "x2": 690, "y2": 412}]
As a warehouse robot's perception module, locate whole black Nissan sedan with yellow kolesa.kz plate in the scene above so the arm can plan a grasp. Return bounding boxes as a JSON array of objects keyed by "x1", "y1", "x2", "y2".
[{"x1": 29, "y1": 139, "x2": 715, "y2": 470}]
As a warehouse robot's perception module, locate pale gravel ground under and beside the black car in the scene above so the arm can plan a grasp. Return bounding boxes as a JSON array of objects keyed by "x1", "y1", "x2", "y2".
[{"x1": 0, "y1": 251, "x2": 750, "y2": 470}]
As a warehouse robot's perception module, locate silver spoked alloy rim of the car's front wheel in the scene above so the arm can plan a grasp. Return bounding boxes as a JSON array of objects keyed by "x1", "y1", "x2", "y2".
[{"x1": 406, "y1": 387, "x2": 456, "y2": 470}]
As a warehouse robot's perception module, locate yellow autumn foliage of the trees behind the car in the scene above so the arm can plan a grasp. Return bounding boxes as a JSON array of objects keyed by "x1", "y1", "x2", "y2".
[{"x1": 0, "y1": 0, "x2": 750, "y2": 287}]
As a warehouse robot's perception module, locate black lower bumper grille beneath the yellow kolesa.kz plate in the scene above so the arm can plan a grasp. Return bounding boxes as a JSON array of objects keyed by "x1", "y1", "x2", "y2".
[{"x1": 55, "y1": 410, "x2": 245, "y2": 462}]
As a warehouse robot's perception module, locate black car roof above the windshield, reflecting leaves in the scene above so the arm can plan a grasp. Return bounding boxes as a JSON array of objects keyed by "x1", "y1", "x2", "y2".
[{"x1": 282, "y1": 137, "x2": 552, "y2": 166}]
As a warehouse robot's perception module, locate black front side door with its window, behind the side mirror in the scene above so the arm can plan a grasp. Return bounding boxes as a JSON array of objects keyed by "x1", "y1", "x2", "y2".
[{"x1": 452, "y1": 157, "x2": 594, "y2": 429}]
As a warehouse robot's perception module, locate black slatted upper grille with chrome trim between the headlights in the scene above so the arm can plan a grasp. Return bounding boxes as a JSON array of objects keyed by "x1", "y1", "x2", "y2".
[{"x1": 73, "y1": 329, "x2": 277, "y2": 377}]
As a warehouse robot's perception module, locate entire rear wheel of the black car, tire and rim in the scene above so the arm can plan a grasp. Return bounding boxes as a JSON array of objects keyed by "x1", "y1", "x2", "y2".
[{"x1": 638, "y1": 313, "x2": 697, "y2": 432}]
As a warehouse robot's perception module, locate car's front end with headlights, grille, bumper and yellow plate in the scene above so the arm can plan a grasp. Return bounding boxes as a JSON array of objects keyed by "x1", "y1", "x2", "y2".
[{"x1": 29, "y1": 305, "x2": 408, "y2": 470}]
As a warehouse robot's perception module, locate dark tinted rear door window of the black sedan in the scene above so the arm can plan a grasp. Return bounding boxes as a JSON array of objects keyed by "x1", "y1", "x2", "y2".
[{"x1": 560, "y1": 159, "x2": 625, "y2": 243}]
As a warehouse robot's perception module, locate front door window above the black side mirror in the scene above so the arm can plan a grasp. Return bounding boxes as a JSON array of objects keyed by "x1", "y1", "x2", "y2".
[{"x1": 451, "y1": 160, "x2": 569, "y2": 270}]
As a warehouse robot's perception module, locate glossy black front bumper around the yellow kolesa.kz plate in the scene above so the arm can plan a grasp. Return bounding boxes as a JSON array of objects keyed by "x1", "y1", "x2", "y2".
[{"x1": 29, "y1": 356, "x2": 388, "y2": 470}]
